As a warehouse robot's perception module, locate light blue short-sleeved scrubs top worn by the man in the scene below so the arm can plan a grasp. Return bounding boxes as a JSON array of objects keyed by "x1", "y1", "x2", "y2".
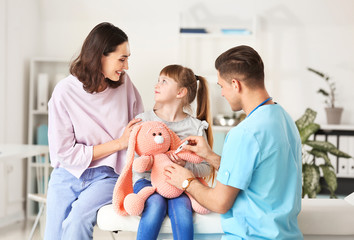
[{"x1": 217, "y1": 104, "x2": 303, "y2": 239}]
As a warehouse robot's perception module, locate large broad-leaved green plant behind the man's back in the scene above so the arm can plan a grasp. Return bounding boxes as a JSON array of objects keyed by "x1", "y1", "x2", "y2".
[{"x1": 295, "y1": 108, "x2": 351, "y2": 198}]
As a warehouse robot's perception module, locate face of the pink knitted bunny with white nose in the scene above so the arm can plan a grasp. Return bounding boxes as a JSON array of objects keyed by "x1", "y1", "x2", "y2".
[{"x1": 135, "y1": 122, "x2": 171, "y2": 155}]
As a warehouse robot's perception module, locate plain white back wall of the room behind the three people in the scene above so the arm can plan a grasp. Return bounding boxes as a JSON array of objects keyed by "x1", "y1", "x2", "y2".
[{"x1": 0, "y1": 0, "x2": 354, "y2": 142}]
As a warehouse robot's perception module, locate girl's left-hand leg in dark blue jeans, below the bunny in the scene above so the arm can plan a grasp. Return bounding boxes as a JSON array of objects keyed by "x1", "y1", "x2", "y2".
[{"x1": 134, "y1": 179, "x2": 167, "y2": 240}]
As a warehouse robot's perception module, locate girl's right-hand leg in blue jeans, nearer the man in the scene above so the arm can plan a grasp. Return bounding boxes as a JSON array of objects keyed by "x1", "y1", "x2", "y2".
[{"x1": 168, "y1": 193, "x2": 194, "y2": 240}]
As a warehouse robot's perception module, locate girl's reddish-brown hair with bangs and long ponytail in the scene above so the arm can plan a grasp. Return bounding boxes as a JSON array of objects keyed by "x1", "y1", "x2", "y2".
[{"x1": 160, "y1": 65, "x2": 215, "y2": 181}]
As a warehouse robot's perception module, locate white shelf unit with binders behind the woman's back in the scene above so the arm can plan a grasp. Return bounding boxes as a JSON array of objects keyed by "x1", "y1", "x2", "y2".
[{"x1": 26, "y1": 57, "x2": 69, "y2": 219}]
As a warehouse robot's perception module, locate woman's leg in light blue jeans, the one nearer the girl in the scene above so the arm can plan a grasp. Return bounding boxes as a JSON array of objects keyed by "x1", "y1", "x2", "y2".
[{"x1": 62, "y1": 166, "x2": 118, "y2": 239}]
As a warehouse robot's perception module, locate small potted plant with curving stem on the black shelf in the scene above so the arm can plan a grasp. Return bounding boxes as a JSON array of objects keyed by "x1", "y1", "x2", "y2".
[{"x1": 307, "y1": 68, "x2": 343, "y2": 124}]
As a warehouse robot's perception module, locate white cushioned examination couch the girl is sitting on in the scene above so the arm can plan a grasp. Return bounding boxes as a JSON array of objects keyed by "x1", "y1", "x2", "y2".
[{"x1": 97, "y1": 199, "x2": 354, "y2": 240}]
